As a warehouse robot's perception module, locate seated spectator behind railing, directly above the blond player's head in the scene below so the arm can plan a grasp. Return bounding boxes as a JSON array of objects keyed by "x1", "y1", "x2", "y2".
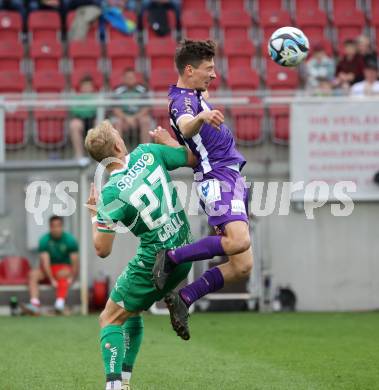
[{"x1": 112, "y1": 69, "x2": 151, "y2": 143}]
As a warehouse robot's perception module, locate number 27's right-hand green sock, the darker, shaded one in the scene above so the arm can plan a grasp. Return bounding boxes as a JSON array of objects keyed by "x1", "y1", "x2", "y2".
[{"x1": 122, "y1": 316, "x2": 143, "y2": 379}]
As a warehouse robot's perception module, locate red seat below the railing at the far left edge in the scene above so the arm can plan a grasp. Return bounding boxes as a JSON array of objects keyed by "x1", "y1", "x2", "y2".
[{"x1": 5, "y1": 111, "x2": 28, "y2": 150}]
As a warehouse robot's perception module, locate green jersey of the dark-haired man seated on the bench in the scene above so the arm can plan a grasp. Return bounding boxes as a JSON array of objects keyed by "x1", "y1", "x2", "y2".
[{"x1": 38, "y1": 232, "x2": 79, "y2": 264}]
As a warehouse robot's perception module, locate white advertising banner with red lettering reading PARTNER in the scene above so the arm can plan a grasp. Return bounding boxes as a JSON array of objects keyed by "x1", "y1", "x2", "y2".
[{"x1": 290, "y1": 99, "x2": 379, "y2": 201}]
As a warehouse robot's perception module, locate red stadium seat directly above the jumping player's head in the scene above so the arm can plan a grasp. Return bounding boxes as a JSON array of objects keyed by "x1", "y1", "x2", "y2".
[{"x1": 182, "y1": 8, "x2": 213, "y2": 39}]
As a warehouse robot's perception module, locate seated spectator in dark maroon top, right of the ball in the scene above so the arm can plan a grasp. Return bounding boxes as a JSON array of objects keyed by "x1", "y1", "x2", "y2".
[{"x1": 336, "y1": 39, "x2": 364, "y2": 89}]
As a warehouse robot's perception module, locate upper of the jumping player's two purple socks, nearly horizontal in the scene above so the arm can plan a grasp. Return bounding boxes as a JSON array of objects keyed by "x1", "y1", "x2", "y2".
[{"x1": 168, "y1": 236, "x2": 225, "y2": 264}]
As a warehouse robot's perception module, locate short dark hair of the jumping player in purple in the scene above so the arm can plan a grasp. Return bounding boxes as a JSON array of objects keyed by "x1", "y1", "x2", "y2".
[{"x1": 175, "y1": 39, "x2": 216, "y2": 74}]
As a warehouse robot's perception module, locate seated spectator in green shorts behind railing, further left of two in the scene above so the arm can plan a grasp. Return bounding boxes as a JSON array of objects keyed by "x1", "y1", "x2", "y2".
[{"x1": 68, "y1": 76, "x2": 96, "y2": 158}]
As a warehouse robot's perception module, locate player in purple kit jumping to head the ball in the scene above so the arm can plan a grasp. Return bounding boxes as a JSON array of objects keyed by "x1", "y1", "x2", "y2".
[{"x1": 151, "y1": 40, "x2": 253, "y2": 338}]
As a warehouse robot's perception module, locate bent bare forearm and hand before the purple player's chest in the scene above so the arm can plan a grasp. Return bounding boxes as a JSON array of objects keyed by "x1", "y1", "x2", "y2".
[{"x1": 178, "y1": 110, "x2": 224, "y2": 138}]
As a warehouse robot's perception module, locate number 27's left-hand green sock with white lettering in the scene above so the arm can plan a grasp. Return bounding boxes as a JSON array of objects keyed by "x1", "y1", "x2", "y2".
[{"x1": 100, "y1": 325, "x2": 125, "y2": 382}]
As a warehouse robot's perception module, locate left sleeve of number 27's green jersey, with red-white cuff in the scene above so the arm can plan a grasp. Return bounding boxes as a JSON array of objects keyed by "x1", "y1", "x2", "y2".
[{"x1": 97, "y1": 187, "x2": 127, "y2": 233}]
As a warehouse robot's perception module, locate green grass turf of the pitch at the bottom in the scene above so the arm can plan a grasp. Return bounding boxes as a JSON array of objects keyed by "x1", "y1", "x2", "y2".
[{"x1": 0, "y1": 313, "x2": 379, "y2": 390}]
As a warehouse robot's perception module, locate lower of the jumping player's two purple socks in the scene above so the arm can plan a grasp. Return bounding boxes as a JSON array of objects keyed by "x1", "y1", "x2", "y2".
[{"x1": 179, "y1": 267, "x2": 224, "y2": 307}]
